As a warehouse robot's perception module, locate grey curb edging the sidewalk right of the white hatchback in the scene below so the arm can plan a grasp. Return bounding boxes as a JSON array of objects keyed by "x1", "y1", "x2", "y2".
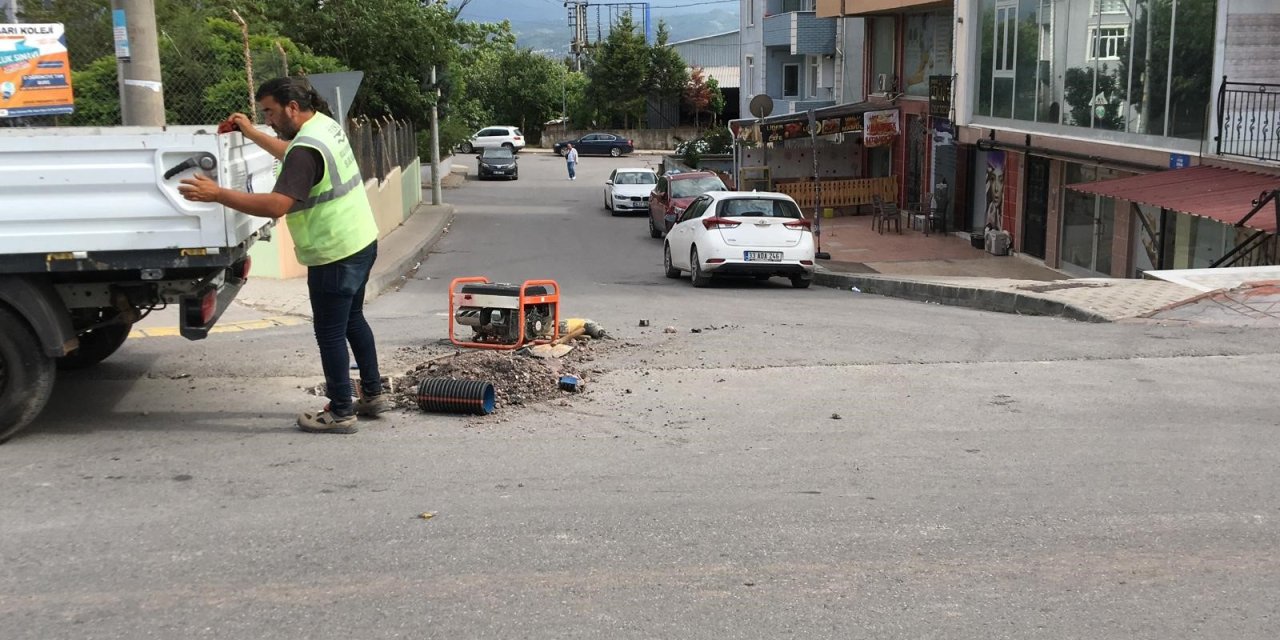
[{"x1": 813, "y1": 270, "x2": 1112, "y2": 323}]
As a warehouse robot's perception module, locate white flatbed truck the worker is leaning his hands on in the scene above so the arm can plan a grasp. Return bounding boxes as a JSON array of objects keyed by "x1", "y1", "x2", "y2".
[{"x1": 0, "y1": 125, "x2": 275, "y2": 442}]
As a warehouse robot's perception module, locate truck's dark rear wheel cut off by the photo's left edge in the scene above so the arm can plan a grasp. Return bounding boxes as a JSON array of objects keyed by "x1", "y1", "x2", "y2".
[{"x1": 0, "y1": 307, "x2": 55, "y2": 443}]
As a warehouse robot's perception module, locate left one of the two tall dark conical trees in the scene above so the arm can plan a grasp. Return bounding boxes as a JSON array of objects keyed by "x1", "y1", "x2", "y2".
[{"x1": 586, "y1": 13, "x2": 650, "y2": 128}]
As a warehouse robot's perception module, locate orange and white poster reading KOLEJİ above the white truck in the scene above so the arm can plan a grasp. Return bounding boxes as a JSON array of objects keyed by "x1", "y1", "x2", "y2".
[{"x1": 0, "y1": 24, "x2": 74, "y2": 118}]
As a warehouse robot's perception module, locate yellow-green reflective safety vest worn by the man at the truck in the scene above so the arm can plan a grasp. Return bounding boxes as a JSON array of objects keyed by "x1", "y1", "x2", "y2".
[{"x1": 275, "y1": 113, "x2": 378, "y2": 266}]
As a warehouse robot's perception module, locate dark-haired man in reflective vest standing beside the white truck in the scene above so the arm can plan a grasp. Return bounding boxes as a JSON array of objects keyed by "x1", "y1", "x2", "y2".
[{"x1": 179, "y1": 78, "x2": 392, "y2": 434}]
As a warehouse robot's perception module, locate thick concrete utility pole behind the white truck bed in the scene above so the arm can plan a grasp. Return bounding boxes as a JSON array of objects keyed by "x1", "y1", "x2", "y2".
[{"x1": 111, "y1": 0, "x2": 165, "y2": 127}]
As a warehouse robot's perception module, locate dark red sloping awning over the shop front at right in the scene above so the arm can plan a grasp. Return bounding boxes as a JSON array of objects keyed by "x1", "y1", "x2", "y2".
[{"x1": 1066, "y1": 166, "x2": 1280, "y2": 233}]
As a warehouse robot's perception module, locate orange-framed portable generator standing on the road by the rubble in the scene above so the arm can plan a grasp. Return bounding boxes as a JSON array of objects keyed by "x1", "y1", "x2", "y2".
[{"x1": 449, "y1": 278, "x2": 559, "y2": 348}]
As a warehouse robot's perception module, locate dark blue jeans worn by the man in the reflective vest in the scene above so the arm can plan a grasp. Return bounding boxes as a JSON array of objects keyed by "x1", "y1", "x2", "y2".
[{"x1": 307, "y1": 241, "x2": 383, "y2": 416}]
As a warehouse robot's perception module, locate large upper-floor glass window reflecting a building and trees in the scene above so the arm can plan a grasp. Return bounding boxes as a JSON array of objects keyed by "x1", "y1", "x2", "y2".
[{"x1": 974, "y1": 0, "x2": 1217, "y2": 143}]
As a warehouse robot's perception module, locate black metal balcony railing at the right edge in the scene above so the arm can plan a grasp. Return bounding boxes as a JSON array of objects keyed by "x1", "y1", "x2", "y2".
[{"x1": 1215, "y1": 77, "x2": 1280, "y2": 160}]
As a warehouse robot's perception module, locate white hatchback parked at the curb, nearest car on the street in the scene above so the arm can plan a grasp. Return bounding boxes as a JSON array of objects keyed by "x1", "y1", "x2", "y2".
[{"x1": 663, "y1": 191, "x2": 814, "y2": 289}]
